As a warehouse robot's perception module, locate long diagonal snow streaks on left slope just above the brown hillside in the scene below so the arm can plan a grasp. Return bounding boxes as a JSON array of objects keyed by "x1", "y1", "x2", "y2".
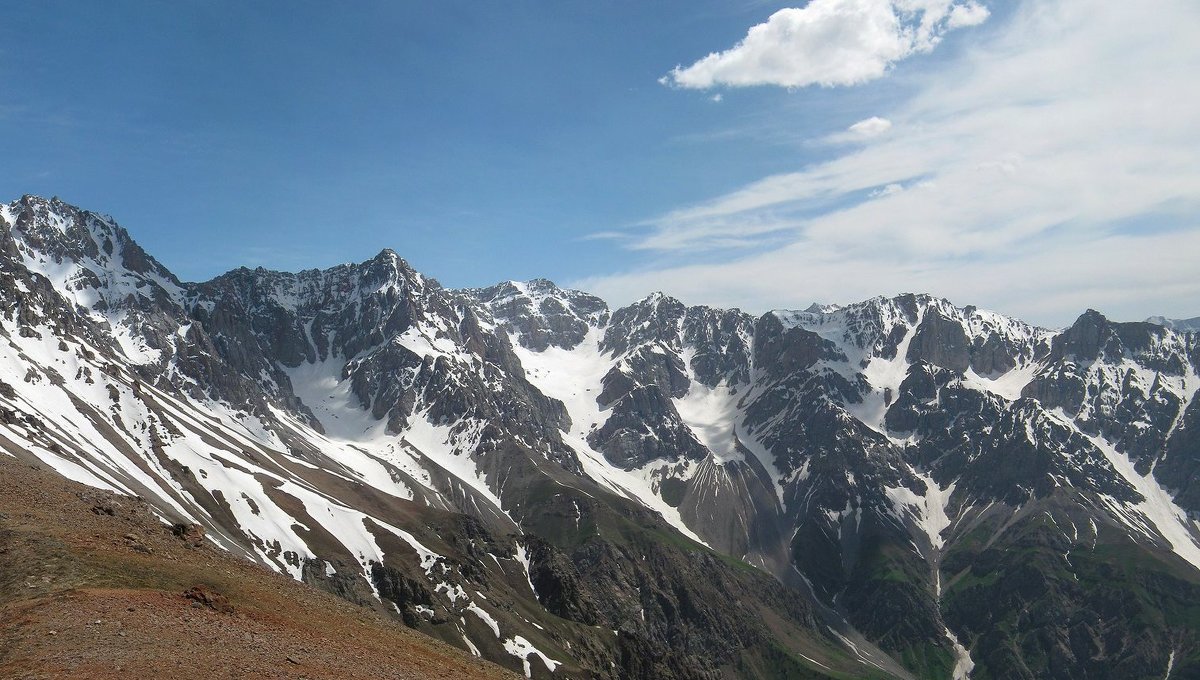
[{"x1": 0, "y1": 316, "x2": 453, "y2": 583}]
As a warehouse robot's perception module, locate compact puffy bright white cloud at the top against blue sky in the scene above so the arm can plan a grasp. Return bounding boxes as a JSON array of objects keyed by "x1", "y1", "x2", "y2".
[{"x1": 661, "y1": 0, "x2": 988, "y2": 90}]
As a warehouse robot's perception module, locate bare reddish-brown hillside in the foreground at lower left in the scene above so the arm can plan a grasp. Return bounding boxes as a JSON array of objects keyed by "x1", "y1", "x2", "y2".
[{"x1": 0, "y1": 455, "x2": 514, "y2": 680}]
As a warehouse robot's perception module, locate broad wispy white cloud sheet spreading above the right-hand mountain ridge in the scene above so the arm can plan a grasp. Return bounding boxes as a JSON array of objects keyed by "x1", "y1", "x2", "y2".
[{"x1": 577, "y1": 0, "x2": 1200, "y2": 324}]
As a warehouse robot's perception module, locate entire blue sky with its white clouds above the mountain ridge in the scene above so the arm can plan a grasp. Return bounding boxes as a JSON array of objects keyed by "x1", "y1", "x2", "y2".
[{"x1": 0, "y1": 0, "x2": 1200, "y2": 326}]
